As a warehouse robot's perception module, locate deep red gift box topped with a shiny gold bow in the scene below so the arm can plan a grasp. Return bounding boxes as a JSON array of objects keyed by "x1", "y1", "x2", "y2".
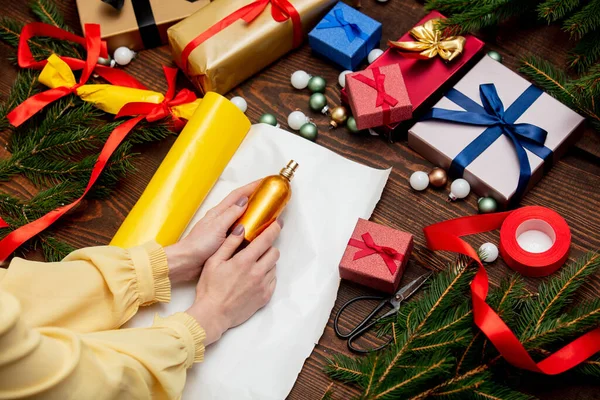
[{"x1": 342, "y1": 11, "x2": 484, "y2": 135}]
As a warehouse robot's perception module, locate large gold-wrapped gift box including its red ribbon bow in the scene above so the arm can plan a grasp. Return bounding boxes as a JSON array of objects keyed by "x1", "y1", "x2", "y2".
[{"x1": 168, "y1": 0, "x2": 335, "y2": 94}]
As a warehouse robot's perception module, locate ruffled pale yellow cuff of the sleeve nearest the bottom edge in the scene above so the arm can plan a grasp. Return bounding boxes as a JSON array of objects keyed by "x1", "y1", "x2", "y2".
[{"x1": 154, "y1": 312, "x2": 206, "y2": 368}]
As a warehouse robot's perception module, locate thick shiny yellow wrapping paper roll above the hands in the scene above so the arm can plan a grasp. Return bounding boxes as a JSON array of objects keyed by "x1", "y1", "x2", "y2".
[{"x1": 110, "y1": 92, "x2": 250, "y2": 247}]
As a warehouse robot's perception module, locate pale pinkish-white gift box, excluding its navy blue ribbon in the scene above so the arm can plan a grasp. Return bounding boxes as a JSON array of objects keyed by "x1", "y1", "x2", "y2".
[{"x1": 408, "y1": 56, "x2": 584, "y2": 206}]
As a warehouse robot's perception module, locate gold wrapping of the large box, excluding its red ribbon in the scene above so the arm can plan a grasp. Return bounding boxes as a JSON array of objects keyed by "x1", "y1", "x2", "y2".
[{"x1": 167, "y1": 0, "x2": 337, "y2": 94}]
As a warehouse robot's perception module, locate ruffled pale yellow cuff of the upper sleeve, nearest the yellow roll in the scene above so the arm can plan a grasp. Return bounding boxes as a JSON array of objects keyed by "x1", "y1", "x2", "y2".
[{"x1": 129, "y1": 241, "x2": 171, "y2": 305}]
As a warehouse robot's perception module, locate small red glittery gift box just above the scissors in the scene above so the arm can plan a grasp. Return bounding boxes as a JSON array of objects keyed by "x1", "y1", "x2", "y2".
[{"x1": 340, "y1": 218, "x2": 413, "y2": 293}]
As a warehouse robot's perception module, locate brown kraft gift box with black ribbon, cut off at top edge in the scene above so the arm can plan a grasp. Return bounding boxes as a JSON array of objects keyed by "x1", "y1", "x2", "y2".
[{"x1": 77, "y1": 0, "x2": 212, "y2": 53}]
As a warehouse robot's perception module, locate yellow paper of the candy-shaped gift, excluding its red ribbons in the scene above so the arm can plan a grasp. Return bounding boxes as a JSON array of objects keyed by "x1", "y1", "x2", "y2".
[{"x1": 39, "y1": 54, "x2": 202, "y2": 120}]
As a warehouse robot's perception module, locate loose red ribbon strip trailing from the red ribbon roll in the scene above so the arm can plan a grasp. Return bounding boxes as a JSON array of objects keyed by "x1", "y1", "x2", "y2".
[{"x1": 423, "y1": 211, "x2": 600, "y2": 375}]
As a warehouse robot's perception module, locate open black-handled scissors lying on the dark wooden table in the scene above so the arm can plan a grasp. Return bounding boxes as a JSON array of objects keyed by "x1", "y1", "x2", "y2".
[{"x1": 333, "y1": 272, "x2": 433, "y2": 353}]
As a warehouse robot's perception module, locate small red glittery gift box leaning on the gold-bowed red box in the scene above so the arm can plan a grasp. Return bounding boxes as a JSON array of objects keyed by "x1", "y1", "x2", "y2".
[{"x1": 346, "y1": 64, "x2": 412, "y2": 129}]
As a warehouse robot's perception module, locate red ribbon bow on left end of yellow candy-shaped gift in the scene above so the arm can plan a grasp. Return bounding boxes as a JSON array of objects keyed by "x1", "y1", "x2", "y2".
[{"x1": 6, "y1": 22, "x2": 145, "y2": 127}]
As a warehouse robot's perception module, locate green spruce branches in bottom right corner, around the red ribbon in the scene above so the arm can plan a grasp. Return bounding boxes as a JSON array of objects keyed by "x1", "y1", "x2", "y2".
[{"x1": 325, "y1": 253, "x2": 600, "y2": 400}]
